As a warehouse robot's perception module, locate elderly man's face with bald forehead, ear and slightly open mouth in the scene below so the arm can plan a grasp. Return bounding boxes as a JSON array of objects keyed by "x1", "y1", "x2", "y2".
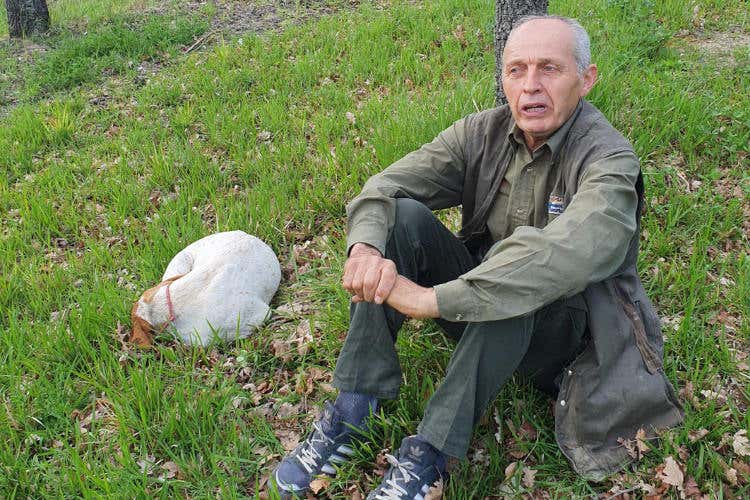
[{"x1": 503, "y1": 19, "x2": 596, "y2": 151}]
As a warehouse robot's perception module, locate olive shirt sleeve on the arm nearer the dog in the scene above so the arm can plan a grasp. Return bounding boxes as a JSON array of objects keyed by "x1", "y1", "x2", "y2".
[{"x1": 346, "y1": 119, "x2": 466, "y2": 255}]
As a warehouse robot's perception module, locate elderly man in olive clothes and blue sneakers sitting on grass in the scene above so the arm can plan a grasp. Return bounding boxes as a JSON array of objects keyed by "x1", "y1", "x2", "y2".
[{"x1": 275, "y1": 16, "x2": 682, "y2": 499}]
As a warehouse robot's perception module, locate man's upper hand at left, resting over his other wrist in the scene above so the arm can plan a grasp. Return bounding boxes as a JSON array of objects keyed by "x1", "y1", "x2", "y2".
[{"x1": 342, "y1": 243, "x2": 398, "y2": 304}]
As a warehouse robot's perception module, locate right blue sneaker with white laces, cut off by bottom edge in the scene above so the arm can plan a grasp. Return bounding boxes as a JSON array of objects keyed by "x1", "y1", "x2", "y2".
[{"x1": 367, "y1": 436, "x2": 447, "y2": 500}]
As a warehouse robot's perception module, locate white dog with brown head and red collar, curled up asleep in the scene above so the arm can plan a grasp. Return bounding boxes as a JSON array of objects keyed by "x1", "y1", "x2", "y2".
[{"x1": 130, "y1": 231, "x2": 281, "y2": 346}]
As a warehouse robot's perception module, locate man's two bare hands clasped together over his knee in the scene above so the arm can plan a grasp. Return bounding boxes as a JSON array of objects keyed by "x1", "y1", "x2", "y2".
[{"x1": 342, "y1": 243, "x2": 439, "y2": 318}]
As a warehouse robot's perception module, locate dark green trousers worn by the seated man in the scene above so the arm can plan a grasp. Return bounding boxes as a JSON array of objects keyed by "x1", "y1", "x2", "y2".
[{"x1": 334, "y1": 199, "x2": 586, "y2": 458}]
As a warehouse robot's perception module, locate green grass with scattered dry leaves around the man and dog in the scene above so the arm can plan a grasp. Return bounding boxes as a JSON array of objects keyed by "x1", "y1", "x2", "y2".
[{"x1": 0, "y1": 0, "x2": 750, "y2": 498}]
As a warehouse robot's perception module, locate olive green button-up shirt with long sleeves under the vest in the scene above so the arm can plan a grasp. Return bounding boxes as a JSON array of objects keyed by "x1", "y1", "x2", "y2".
[{"x1": 347, "y1": 103, "x2": 639, "y2": 321}]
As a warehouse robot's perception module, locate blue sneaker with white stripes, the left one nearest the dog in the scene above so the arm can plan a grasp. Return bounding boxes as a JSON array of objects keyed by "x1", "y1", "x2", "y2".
[{"x1": 274, "y1": 401, "x2": 359, "y2": 498}]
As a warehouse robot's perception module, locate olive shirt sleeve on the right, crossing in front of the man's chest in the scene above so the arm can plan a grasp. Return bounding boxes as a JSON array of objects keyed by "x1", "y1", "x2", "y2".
[{"x1": 435, "y1": 152, "x2": 640, "y2": 321}]
